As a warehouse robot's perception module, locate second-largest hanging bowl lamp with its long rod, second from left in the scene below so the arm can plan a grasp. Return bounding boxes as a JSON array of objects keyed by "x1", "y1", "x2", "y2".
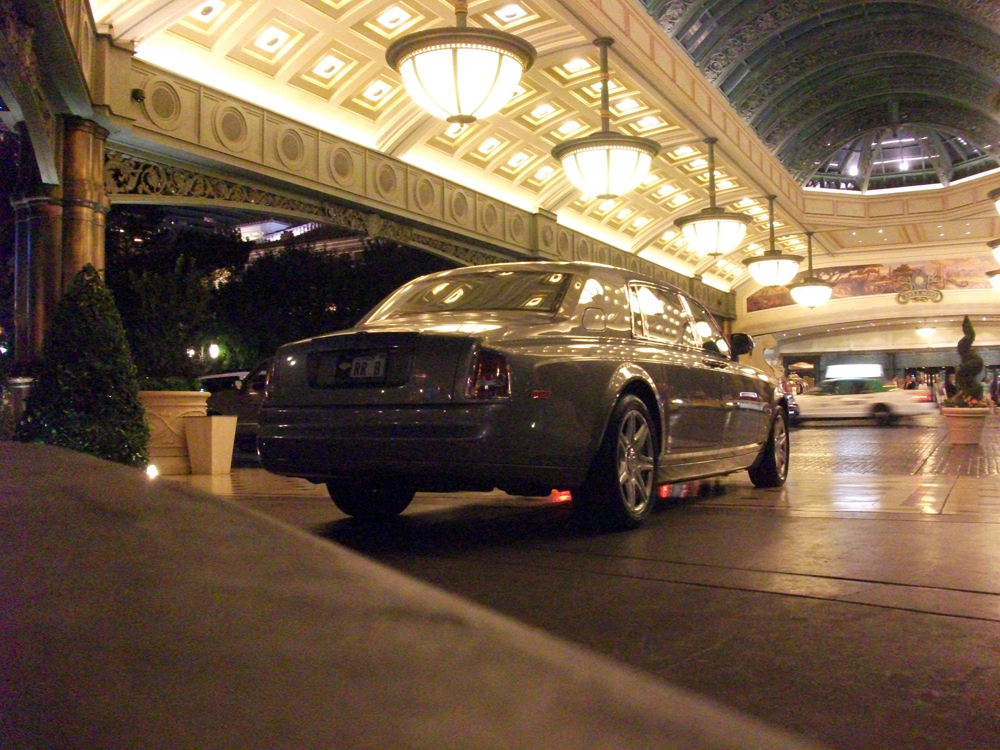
[{"x1": 552, "y1": 37, "x2": 660, "y2": 200}]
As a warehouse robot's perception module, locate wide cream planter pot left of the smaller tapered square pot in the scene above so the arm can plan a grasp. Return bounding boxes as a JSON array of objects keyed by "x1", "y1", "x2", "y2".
[{"x1": 139, "y1": 391, "x2": 209, "y2": 474}]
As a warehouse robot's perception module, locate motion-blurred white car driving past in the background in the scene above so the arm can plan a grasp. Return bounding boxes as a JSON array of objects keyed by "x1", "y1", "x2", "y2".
[{"x1": 793, "y1": 378, "x2": 937, "y2": 425}]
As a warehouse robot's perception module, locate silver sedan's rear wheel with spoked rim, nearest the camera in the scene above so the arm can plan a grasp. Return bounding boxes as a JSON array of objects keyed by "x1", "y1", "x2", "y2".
[{"x1": 573, "y1": 395, "x2": 657, "y2": 531}]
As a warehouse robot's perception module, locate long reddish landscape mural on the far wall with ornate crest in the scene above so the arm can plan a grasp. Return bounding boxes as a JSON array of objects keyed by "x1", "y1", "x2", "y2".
[{"x1": 747, "y1": 258, "x2": 996, "y2": 313}]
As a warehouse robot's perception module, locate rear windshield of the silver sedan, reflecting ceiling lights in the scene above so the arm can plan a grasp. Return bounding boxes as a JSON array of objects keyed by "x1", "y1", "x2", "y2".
[{"x1": 373, "y1": 271, "x2": 572, "y2": 320}]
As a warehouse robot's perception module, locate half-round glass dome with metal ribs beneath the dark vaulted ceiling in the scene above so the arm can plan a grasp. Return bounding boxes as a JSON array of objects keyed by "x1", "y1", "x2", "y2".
[{"x1": 806, "y1": 125, "x2": 1000, "y2": 193}]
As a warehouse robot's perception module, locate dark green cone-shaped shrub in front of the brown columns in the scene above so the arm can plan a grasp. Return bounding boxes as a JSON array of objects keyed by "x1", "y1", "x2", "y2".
[{"x1": 16, "y1": 264, "x2": 149, "y2": 466}]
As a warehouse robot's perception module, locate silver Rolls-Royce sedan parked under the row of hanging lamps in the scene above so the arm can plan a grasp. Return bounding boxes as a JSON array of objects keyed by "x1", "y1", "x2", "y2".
[{"x1": 257, "y1": 262, "x2": 789, "y2": 529}]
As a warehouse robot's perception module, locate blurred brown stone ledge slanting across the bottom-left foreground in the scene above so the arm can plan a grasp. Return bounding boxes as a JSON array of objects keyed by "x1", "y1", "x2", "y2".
[{"x1": 0, "y1": 442, "x2": 824, "y2": 750}]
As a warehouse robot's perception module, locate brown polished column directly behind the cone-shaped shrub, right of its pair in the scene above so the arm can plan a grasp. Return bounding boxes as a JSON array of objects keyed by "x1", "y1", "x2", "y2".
[{"x1": 62, "y1": 117, "x2": 108, "y2": 289}]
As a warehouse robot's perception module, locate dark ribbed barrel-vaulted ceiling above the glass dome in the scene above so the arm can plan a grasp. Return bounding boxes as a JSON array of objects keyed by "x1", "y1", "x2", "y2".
[{"x1": 646, "y1": 0, "x2": 1000, "y2": 189}]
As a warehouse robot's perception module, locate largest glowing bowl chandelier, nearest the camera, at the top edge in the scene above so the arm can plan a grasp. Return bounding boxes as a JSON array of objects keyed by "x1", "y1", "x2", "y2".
[{"x1": 385, "y1": 0, "x2": 536, "y2": 124}]
